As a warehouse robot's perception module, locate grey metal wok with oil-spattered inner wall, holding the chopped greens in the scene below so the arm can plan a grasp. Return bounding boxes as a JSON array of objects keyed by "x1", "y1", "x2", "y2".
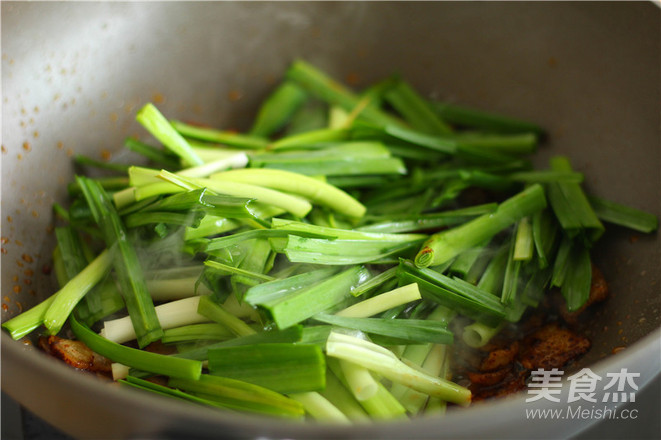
[{"x1": 1, "y1": 2, "x2": 661, "y2": 439}]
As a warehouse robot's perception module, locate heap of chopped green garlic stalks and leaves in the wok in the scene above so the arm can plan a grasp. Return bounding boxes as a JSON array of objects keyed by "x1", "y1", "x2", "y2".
[{"x1": 3, "y1": 60, "x2": 657, "y2": 423}]
